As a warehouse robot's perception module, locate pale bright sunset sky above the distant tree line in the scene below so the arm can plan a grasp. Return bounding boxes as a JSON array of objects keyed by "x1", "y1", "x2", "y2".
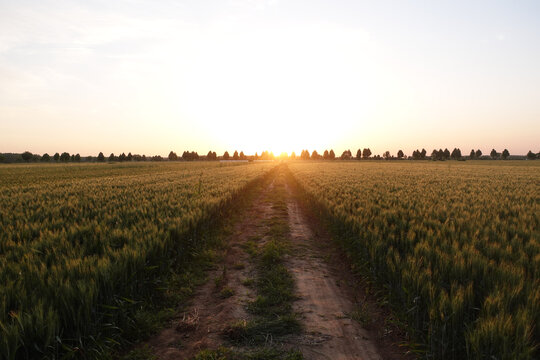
[{"x1": 0, "y1": 0, "x2": 540, "y2": 155}]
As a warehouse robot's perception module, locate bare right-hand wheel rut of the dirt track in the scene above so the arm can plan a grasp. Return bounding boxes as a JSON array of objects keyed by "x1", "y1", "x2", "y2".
[{"x1": 288, "y1": 186, "x2": 382, "y2": 360}]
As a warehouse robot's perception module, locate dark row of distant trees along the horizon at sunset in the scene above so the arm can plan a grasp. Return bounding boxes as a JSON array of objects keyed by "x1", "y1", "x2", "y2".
[{"x1": 0, "y1": 148, "x2": 540, "y2": 163}]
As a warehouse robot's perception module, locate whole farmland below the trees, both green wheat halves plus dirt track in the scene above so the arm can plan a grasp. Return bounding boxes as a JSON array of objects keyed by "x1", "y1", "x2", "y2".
[{"x1": 0, "y1": 161, "x2": 540, "y2": 360}]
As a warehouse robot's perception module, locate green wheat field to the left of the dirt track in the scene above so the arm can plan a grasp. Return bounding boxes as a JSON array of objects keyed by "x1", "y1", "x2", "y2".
[{"x1": 0, "y1": 163, "x2": 273, "y2": 359}]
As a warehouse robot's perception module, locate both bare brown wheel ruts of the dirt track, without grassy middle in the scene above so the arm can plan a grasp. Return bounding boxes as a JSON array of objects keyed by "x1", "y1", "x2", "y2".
[{"x1": 141, "y1": 170, "x2": 410, "y2": 360}]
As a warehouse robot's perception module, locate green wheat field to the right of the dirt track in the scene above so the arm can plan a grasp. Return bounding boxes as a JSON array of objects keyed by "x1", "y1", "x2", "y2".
[{"x1": 288, "y1": 161, "x2": 540, "y2": 359}]
